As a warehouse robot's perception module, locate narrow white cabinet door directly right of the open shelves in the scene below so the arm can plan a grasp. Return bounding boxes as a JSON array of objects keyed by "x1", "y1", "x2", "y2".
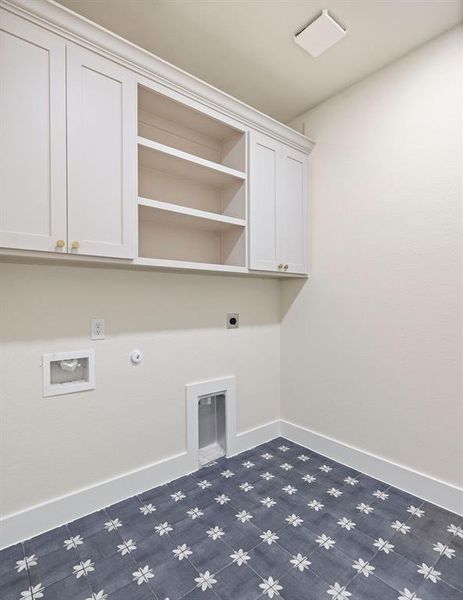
[{"x1": 249, "y1": 132, "x2": 280, "y2": 271}]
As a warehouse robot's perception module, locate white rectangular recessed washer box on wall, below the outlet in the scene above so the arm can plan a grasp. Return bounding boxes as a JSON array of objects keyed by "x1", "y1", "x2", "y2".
[{"x1": 42, "y1": 350, "x2": 95, "y2": 398}]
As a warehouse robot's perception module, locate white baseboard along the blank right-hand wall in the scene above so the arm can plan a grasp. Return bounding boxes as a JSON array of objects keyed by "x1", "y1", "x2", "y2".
[{"x1": 280, "y1": 420, "x2": 463, "y2": 514}]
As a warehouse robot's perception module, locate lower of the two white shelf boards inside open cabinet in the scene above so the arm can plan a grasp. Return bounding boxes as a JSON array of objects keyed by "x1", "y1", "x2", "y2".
[{"x1": 138, "y1": 197, "x2": 246, "y2": 231}]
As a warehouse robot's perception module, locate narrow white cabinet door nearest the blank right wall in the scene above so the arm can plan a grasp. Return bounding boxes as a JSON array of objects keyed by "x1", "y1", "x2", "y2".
[{"x1": 277, "y1": 145, "x2": 309, "y2": 274}]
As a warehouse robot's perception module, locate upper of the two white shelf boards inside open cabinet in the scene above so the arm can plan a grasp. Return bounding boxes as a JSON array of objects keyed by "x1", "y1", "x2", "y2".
[{"x1": 138, "y1": 136, "x2": 246, "y2": 187}]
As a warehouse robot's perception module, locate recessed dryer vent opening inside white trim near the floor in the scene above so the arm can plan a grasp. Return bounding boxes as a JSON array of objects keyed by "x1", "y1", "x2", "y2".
[{"x1": 198, "y1": 394, "x2": 227, "y2": 466}]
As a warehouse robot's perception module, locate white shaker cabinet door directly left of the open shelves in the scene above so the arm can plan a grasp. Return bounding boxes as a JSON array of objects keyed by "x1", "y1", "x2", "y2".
[{"x1": 67, "y1": 45, "x2": 137, "y2": 258}]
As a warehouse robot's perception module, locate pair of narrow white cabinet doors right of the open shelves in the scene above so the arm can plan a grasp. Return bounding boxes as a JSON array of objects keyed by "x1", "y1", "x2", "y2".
[{"x1": 250, "y1": 133, "x2": 308, "y2": 274}]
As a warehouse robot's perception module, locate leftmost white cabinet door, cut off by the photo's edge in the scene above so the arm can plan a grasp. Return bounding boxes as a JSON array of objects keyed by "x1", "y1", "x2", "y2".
[{"x1": 0, "y1": 9, "x2": 66, "y2": 252}]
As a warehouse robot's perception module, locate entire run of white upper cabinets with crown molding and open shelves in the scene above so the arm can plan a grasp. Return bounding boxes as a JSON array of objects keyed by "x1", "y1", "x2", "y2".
[{"x1": 0, "y1": 0, "x2": 313, "y2": 276}]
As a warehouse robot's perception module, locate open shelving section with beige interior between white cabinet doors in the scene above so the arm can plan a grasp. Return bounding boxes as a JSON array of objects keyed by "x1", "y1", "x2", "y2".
[{"x1": 137, "y1": 85, "x2": 247, "y2": 272}]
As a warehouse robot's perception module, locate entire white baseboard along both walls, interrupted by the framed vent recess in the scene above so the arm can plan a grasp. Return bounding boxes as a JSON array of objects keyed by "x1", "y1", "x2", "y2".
[{"x1": 0, "y1": 420, "x2": 463, "y2": 548}]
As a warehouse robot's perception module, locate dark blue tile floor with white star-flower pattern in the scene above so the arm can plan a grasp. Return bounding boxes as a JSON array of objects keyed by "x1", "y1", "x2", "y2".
[{"x1": 0, "y1": 438, "x2": 463, "y2": 600}]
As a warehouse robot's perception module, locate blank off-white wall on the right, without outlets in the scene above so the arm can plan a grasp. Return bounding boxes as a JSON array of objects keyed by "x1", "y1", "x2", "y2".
[{"x1": 281, "y1": 27, "x2": 463, "y2": 485}]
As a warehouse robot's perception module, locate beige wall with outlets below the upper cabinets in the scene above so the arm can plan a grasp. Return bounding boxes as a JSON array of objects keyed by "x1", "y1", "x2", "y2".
[{"x1": 0, "y1": 264, "x2": 280, "y2": 514}]
